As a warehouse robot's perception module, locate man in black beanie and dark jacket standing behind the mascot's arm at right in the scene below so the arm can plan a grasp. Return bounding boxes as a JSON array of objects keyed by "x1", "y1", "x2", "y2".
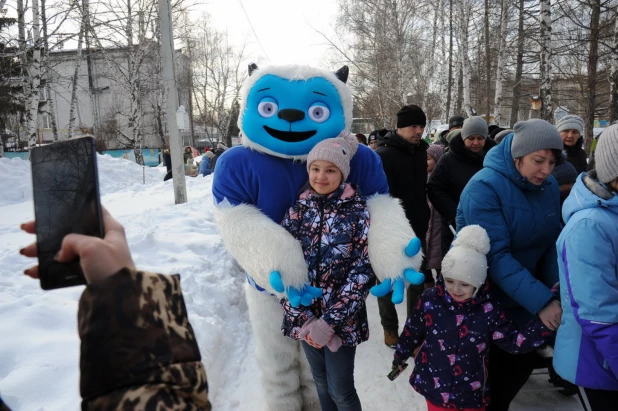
[{"x1": 376, "y1": 105, "x2": 433, "y2": 348}]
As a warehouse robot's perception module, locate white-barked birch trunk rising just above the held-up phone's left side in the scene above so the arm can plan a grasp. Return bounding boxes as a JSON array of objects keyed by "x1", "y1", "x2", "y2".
[{"x1": 26, "y1": 0, "x2": 41, "y2": 146}]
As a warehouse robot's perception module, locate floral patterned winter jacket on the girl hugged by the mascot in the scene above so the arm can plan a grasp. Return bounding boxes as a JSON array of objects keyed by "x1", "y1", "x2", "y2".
[{"x1": 281, "y1": 184, "x2": 376, "y2": 346}]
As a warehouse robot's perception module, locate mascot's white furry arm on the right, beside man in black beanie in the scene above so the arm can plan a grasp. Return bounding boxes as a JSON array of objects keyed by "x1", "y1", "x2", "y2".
[{"x1": 367, "y1": 194, "x2": 423, "y2": 281}]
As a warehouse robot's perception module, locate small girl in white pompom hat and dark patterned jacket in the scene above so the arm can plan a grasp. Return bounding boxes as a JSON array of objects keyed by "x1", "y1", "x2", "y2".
[{"x1": 393, "y1": 225, "x2": 552, "y2": 411}]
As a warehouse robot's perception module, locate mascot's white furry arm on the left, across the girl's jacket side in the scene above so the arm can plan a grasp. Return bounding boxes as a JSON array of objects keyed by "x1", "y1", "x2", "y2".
[{"x1": 217, "y1": 204, "x2": 308, "y2": 296}]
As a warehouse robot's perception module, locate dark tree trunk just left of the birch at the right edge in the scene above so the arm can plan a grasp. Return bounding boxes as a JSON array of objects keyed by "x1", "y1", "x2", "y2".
[{"x1": 584, "y1": 0, "x2": 601, "y2": 153}]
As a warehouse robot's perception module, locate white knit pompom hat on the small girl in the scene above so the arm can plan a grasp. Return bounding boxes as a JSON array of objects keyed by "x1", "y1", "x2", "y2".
[{"x1": 442, "y1": 225, "x2": 490, "y2": 294}]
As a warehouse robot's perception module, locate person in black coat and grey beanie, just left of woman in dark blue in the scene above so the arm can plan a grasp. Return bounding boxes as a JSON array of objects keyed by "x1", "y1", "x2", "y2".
[{"x1": 427, "y1": 116, "x2": 496, "y2": 255}]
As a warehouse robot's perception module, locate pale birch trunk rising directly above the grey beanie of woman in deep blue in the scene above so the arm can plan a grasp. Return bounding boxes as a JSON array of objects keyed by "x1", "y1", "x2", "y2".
[{"x1": 539, "y1": 0, "x2": 552, "y2": 122}]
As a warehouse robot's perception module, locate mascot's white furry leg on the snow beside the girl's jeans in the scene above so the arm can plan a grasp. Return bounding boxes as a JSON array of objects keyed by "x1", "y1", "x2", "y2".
[{"x1": 245, "y1": 285, "x2": 306, "y2": 411}]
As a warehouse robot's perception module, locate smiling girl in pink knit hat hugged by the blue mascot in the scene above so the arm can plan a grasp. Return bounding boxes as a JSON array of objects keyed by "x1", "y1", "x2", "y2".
[{"x1": 281, "y1": 135, "x2": 376, "y2": 410}]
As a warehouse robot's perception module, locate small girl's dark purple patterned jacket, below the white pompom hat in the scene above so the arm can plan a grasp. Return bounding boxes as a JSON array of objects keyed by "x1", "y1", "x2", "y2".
[{"x1": 393, "y1": 281, "x2": 552, "y2": 409}]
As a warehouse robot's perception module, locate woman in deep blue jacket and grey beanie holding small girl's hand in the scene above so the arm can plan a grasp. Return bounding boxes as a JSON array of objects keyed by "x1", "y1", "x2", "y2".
[{"x1": 457, "y1": 119, "x2": 562, "y2": 411}]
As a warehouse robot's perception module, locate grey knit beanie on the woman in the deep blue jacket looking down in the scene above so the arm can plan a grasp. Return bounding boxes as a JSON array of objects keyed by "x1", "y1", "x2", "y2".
[{"x1": 511, "y1": 118, "x2": 564, "y2": 158}]
